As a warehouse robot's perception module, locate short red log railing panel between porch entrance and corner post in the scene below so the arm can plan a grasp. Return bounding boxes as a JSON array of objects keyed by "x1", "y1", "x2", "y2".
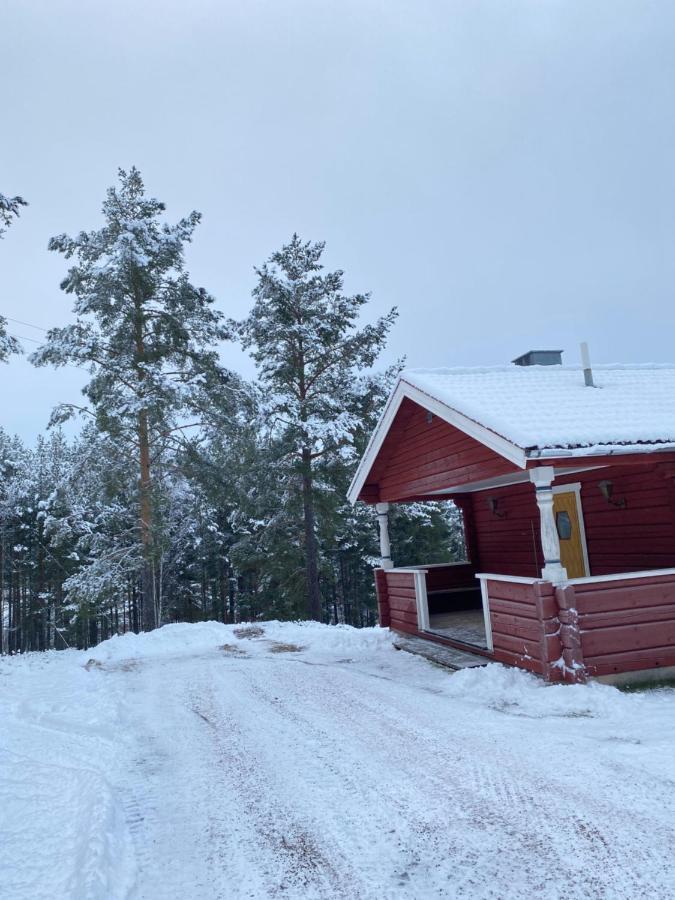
[{"x1": 487, "y1": 579, "x2": 562, "y2": 681}]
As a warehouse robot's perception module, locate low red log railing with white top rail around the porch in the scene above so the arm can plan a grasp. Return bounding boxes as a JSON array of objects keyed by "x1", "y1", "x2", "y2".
[{"x1": 375, "y1": 564, "x2": 675, "y2": 681}]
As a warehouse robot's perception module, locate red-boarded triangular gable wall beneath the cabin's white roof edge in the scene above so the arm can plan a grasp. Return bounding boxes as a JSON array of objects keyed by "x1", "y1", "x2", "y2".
[{"x1": 367, "y1": 399, "x2": 518, "y2": 501}]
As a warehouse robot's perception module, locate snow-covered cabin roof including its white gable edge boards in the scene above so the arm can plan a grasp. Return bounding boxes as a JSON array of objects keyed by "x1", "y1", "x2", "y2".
[{"x1": 349, "y1": 365, "x2": 675, "y2": 500}]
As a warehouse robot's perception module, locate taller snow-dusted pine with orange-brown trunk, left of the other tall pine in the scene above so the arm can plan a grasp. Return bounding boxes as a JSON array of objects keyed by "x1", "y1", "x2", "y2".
[{"x1": 32, "y1": 168, "x2": 226, "y2": 628}]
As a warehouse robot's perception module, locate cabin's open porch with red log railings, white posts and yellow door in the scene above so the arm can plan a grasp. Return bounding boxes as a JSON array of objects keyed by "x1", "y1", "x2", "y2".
[{"x1": 375, "y1": 466, "x2": 675, "y2": 681}]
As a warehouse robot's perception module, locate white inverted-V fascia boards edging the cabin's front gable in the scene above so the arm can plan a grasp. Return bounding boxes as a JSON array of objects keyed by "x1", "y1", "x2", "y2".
[{"x1": 347, "y1": 378, "x2": 527, "y2": 504}]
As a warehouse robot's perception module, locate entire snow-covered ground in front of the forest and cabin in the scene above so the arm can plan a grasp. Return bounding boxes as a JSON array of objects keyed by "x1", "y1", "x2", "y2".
[{"x1": 0, "y1": 623, "x2": 675, "y2": 900}]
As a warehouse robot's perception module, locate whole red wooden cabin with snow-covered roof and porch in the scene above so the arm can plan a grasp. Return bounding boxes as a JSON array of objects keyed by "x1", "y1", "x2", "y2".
[{"x1": 349, "y1": 353, "x2": 675, "y2": 681}]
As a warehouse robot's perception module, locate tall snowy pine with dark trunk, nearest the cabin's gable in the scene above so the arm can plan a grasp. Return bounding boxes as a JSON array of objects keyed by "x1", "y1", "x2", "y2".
[{"x1": 236, "y1": 234, "x2": 397, "y2": 619}]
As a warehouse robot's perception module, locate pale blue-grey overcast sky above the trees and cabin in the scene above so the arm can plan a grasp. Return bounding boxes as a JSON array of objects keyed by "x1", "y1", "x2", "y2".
[{"x1": 0, "y1": 0, "x2": 675, "y2": 441}]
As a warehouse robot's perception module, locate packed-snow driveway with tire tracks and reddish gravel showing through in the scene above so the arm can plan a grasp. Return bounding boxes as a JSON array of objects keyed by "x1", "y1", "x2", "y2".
[{"x1": 113, "y1": 655, "x2": 675, "y2": 900}]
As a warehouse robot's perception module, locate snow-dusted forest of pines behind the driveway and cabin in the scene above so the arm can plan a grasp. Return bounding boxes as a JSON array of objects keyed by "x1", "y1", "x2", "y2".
[{"x1": 0, "y1": 169, "x2": 463, "y2": 653}]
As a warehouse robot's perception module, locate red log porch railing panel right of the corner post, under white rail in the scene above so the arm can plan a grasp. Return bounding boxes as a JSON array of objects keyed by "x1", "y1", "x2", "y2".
[{"x1": 573, "y1": 575, "x2": 675, "y2": 675}]
